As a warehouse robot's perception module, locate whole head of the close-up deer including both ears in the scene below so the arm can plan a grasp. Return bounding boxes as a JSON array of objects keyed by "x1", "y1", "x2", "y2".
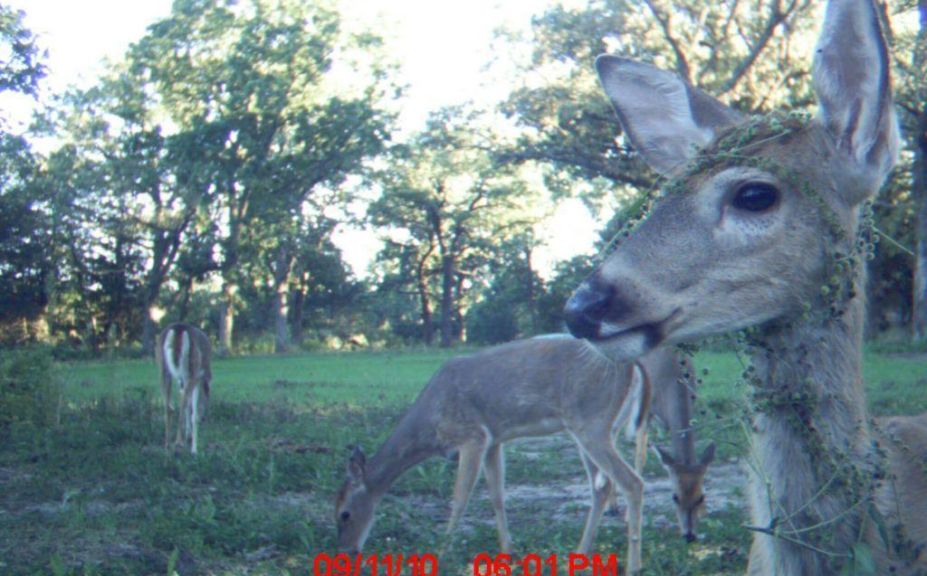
[{"x1": 564, "y1": 2, "x2": 897, "y2": 360}]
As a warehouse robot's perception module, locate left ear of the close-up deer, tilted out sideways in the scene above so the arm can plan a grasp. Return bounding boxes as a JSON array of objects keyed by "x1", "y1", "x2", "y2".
[{"x1": 595, "y1": 55, "x2": 741, "y2": 174}]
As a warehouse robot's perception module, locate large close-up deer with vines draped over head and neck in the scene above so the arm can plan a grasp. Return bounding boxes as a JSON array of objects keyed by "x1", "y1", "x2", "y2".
[{"x1": 565, "y1": 0, "x2": 927, "y2": 576}]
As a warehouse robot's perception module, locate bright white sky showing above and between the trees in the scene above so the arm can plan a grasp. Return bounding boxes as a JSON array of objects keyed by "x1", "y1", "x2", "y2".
[{"x1": 0, "y1": 0, "x2": 595, "y2": 275}]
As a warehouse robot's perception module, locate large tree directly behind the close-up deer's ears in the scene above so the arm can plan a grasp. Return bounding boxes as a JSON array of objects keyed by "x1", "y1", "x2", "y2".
[{"x1": 499, "y1": 0, "x2": 927, "y2": 338}]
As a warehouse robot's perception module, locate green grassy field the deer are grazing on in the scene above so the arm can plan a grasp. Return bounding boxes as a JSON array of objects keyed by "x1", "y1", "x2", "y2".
[{"x1": 0, "y1": 350, "x2": 927, "y2": 575}]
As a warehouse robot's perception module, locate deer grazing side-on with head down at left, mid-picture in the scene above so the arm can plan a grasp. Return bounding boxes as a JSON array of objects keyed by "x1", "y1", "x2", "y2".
[{"x1": 335, "y1": 335, "x2": 648, "y2": 571}]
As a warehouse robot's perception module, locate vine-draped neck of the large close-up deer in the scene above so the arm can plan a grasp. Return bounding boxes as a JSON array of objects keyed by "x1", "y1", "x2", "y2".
[{"x1": 750, "y1": 270, "x2": 875, "y2": 574}]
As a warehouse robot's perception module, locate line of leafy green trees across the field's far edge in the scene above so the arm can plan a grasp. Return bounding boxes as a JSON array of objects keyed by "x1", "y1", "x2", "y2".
[{"x1": 0, "y1": 0, "x2": 927, "y2": 353}]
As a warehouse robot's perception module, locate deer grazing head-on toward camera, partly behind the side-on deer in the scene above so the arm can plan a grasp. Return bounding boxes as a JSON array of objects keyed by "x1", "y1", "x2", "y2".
[{"x1": 610, "y1": 348, "x2": 715, "y2": 542}]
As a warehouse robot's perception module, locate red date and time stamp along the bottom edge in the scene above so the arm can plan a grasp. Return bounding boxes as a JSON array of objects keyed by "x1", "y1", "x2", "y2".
[{"x1": 312, "y1": 552, "x2": 619, "y2": 576}]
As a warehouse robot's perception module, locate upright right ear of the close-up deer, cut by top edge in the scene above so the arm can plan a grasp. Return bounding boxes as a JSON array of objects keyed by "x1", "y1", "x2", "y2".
[{"x1": 813, "y1": 0, "x2": 899, "y2": 197}]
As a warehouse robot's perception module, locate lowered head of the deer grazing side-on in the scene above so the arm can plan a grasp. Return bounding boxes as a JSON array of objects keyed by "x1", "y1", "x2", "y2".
[{"x1": 335, "y1": 448, "x2": 377, "y2": 552}]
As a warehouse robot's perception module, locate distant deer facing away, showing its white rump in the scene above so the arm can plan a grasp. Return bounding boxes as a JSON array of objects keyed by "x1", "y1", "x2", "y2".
[{"x1": 155, "y1": 323, "x2": 212, "y2": 454}]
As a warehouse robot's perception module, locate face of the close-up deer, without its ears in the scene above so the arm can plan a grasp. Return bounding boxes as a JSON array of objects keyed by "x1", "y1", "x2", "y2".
[{"x1": 566, "y1": 121, "x2": 855, "y2": 357}]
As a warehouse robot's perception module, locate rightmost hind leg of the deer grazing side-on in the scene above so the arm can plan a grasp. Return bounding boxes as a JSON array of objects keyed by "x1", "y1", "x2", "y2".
[{"x1": 574, "y1": 424, "x2": 644, "y2": 574}]
